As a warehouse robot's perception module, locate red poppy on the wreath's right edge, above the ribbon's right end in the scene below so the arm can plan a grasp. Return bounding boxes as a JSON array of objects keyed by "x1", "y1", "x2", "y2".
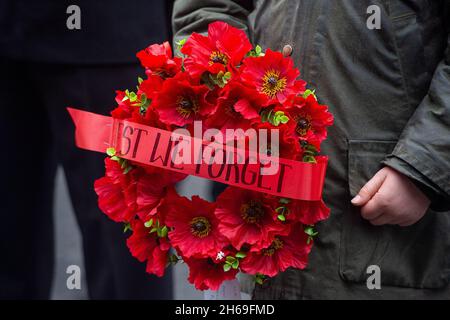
[{"x1": 288, "y1": 95, "x2": 333, "y2": 148}]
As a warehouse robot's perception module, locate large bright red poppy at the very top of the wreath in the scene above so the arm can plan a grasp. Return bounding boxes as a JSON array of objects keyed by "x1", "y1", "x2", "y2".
[{"x1": 181, "y1": 21, "x2": 252, "y2": 78}]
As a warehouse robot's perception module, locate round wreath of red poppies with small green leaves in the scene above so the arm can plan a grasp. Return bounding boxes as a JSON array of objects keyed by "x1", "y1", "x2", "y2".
[{"x1": 71, "y1": 22, "x2": 333, "y2": 290}]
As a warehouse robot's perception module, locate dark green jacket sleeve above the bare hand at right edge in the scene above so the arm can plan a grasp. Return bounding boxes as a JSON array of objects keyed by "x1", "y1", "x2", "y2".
[{"x1": 383, "y1": 8, "x2": 450, "y2": 211}]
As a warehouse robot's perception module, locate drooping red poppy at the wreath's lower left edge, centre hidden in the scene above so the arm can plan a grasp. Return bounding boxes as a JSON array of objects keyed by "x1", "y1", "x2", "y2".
[{"x1": 127, "y1": 219, "x2": 170, "y2": 277}]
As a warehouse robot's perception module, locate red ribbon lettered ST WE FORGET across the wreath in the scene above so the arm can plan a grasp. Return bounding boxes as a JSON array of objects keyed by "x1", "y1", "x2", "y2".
[{"x1": 68, "y1": 108, "x2": 328, "y2": 201}]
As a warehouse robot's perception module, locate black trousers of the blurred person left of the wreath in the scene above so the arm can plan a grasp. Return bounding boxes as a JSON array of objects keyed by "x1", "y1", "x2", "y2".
[{"x1": 0, "y1": 59, "x2": 172, "y2": 299}]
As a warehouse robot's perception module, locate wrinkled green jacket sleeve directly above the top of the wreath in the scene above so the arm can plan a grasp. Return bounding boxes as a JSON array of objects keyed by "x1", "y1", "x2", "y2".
[{"x1": 172, "y1": 0, "x2": 253, "y2": 47}]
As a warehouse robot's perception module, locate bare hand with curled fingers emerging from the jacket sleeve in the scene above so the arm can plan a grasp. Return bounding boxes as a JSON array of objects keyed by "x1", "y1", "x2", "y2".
[{"x1": 352, "y1": 167, "x2": 430, "y2": 227}]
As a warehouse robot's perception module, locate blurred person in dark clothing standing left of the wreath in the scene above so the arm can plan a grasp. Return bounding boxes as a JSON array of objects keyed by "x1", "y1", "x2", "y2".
[{"x1": 0, "y1": 0, "x2": 172, "y2": 299}]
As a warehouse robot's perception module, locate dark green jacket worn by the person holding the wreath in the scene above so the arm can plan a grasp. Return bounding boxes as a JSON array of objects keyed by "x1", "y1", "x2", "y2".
[{"x1": 173, "y1": 0, "x2": 450, "y2": 299}]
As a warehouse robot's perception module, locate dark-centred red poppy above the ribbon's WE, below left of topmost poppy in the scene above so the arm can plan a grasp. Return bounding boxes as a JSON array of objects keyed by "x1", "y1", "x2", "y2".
[{"x1": 155, "y1": 73, "x2": 216, "y2": 127}]
